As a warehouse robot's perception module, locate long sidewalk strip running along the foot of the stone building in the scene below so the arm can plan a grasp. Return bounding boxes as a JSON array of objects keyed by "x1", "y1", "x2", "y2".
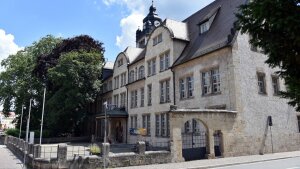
[{"x1": 116, "y1": 151, "x2": 300, "y2": 169}]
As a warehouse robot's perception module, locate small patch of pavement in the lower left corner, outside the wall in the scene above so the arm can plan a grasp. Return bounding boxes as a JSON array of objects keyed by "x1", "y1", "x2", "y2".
[{"x1": 0, "y1": 144, "x2": 22, "y2": 169}]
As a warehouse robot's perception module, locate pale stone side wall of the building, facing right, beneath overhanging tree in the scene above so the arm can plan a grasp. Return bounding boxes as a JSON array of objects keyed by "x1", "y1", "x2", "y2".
[{"x1": 228, "y1": 34, "x2": 300, "y2": 156}]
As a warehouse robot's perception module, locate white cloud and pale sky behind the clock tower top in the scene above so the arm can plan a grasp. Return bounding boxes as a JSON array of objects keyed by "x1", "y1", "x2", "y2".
[{"x1": 102, "y1": 0, "x2": 213, "y2": 50}]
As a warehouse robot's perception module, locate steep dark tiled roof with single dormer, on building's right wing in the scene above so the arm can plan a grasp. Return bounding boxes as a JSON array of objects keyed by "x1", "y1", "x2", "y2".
[{"x1": 173, "y1": 0, "x2": 247, "y2": 66}]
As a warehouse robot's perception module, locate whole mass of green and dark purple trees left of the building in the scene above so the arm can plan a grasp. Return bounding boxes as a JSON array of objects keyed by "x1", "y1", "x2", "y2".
[{"x1": 0, "y1": 35, "x2": 104, "y2": 136}]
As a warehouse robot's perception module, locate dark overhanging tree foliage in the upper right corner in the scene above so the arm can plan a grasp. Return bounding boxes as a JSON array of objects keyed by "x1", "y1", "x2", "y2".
[{"x1": 237, "y1": 0, "x2": 300, "y2": 111}]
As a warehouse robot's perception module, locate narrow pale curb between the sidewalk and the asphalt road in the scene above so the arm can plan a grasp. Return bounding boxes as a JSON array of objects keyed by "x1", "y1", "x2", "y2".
[{"x1": 185, "y1": 155, "x2": 300, "y2": 169}]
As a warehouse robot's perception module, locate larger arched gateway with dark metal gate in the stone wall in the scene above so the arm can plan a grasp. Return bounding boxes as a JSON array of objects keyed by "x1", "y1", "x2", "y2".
[{"x1": 181, "y1": 119, "x2": 207, "y2": 161}]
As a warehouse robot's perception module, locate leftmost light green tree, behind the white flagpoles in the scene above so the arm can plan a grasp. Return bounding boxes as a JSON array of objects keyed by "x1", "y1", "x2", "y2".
[{"x1": 0, "y1": 35, "x2": 61, "y2": 133}]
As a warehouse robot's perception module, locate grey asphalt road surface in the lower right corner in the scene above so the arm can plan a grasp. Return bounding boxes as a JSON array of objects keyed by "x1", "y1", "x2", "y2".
[{"x1": 214, "y1": 157, "x2": 300, "y2": 169}]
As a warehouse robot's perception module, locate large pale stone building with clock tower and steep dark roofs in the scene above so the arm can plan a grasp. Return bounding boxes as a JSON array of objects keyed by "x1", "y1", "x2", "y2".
[{"x1": 91, "y1": 0, "x2": 300, "y2": 161}]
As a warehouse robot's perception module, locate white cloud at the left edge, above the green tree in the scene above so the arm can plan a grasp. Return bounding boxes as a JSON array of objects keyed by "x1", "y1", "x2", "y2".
[{"x1": 0, "y1": 29, "x2": 22, "y2": 61}]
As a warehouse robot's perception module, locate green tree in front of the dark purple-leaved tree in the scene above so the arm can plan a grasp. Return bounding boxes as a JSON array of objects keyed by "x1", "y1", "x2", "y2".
[{"x1": 48, "y1": 51, "x2": 102, "y2": 133}]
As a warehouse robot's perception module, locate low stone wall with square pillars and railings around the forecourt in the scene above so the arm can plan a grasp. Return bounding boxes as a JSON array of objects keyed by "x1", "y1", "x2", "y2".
[{"x1": 6, "y1": 136, "x2": 171, "y2": 169}]
